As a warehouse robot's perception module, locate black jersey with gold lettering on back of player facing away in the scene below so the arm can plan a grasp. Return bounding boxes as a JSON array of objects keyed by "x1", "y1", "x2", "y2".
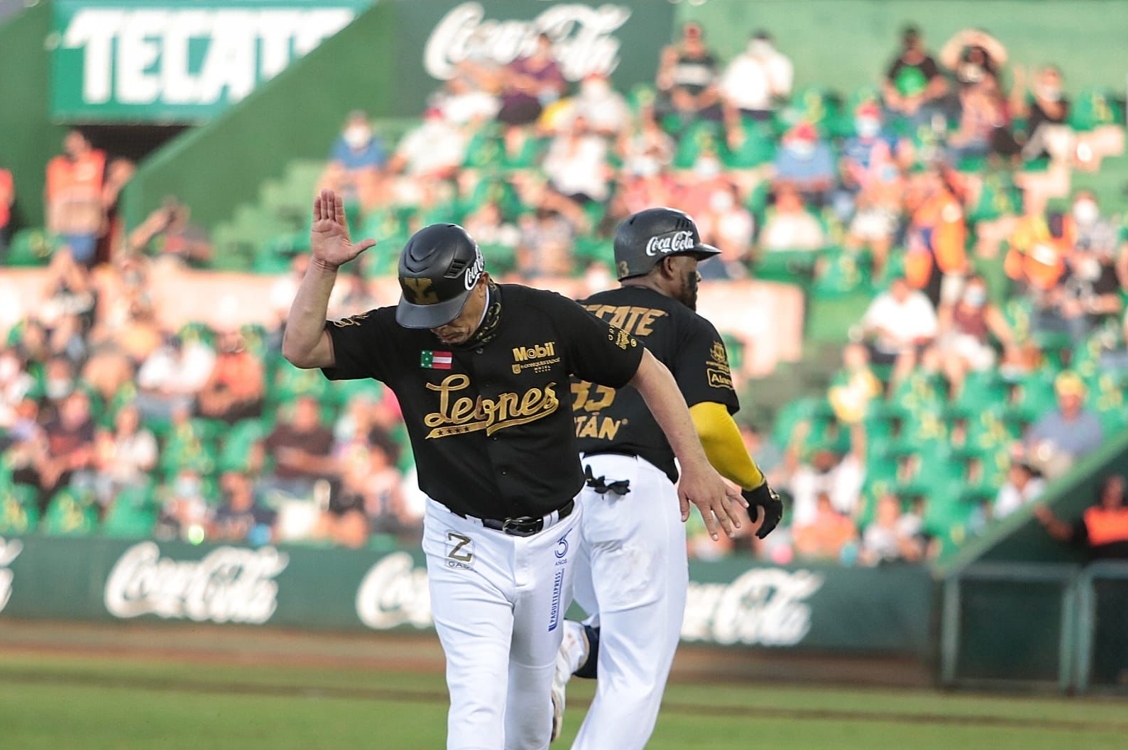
[{"x1": 572, "y1": 285, "x2": 740, "y2": 482}]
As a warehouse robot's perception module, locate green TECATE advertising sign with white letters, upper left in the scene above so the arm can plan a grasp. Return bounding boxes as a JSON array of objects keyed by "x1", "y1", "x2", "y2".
[{"x1": 51, "y1": 0, "x2": 373, "y2": 123}]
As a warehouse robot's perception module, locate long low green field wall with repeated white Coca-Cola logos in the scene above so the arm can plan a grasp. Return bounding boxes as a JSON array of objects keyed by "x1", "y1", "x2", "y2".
[{"x1": 0, "y1": 537, "x2": 933, "y2": 653}]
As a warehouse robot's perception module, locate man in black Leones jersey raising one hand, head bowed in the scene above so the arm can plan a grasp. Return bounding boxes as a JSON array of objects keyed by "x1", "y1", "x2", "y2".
[{"x1": 282, "y1": 191, "x2": 744, "y2": 750}]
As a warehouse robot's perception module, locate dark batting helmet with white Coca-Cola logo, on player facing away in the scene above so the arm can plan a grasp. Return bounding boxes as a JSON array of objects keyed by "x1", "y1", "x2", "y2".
[{"x1": 615, "y1": 208, "x2": 721, "y2": 281}]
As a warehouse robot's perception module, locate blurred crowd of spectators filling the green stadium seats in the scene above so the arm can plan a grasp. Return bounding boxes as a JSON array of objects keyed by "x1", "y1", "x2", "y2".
[{"x1": 0, "y1": 23, "x2": 1128, "y2": 564}]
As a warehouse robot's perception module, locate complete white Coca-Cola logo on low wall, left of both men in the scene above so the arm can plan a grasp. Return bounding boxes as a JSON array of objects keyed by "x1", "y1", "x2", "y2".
[{"x1": 103, "y1": 541, "x2": 290, "y2": 625}]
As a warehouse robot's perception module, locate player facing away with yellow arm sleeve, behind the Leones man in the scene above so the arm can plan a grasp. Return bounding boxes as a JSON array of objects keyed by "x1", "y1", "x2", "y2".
[{"x1": 553, "y1": 209, "x2": 783, "y2": 750}]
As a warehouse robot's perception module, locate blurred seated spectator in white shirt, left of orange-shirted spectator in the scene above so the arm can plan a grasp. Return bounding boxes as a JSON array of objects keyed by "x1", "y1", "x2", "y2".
[{"x1": 134, "y1": 336, "x2": 215, "y2": 421}]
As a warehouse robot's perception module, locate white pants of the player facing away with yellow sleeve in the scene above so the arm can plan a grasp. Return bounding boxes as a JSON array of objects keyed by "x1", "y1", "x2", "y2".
[{"x1": 572, "y1": 455, "x2": 689, "y2": 750}]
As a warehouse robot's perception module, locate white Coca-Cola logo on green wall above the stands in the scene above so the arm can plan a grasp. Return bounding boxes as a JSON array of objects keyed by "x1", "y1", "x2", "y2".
[{"x1": 423, "y1": 2, "x2": 631, "y2": 81}]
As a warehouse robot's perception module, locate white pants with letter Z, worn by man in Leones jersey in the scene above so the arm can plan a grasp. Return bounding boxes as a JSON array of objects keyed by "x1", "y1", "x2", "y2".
[{"x1": 423, "y1": 500, "x2": 582, "y2": 750}]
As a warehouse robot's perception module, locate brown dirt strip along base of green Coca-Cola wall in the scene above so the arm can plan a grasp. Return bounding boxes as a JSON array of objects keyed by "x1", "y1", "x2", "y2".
[{"x1": 0, "y1": 618, "x2": 931, "y2": 687}]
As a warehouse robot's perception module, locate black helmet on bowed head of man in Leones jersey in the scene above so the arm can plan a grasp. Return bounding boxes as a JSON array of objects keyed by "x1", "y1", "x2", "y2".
[{"x1": 396, "y1": 224, "x2": 485, "y2": 328}]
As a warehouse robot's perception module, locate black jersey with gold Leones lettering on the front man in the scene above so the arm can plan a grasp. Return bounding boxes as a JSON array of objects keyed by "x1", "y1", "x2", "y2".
[{"x1": 325, "y1": 284, "x2": 644, "y2": 519}]
